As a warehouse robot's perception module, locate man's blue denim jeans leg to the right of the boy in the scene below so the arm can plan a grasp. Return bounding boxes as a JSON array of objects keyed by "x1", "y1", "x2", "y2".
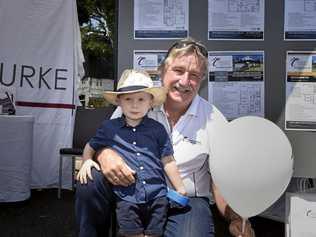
[{"x1": 164, "y1": 198, "x2": 215, "y2": 237}]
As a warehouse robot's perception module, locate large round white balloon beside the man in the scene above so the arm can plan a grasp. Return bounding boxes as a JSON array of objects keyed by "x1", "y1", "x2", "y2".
[{"x1": 210, "y1": 116, "x2": 293, "y2": 218}]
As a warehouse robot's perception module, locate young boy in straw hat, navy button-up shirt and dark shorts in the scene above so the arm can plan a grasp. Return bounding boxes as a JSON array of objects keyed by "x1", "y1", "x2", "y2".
[{"x1": 77, "y1": 70, "x2": 186, "y2": 237}]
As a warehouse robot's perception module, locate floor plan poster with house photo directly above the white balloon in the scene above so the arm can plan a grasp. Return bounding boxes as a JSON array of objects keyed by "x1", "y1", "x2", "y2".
[{"x1": 208, "y1": 51, "x2": 264, "y2": 120}]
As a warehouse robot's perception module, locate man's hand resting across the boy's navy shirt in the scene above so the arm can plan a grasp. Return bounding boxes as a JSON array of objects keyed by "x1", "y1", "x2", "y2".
[{"x1": 96, "y1": 148, "x2": 136, "y2": 187}]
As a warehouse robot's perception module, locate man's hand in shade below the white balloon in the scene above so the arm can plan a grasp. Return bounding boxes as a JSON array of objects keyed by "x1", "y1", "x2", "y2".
[{"x1": 224, "y1": 205, "x2": 256, "y2": 237}]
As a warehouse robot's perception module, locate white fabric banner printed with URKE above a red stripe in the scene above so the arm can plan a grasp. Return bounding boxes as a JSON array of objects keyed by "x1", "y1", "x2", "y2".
[{"x1": 0, "y1": 0, "x2": 83, "y2": 188}]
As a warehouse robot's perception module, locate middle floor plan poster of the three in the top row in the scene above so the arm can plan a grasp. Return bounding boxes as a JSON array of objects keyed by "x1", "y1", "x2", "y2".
[{"x1": 208, "y1": 0, "x2": 264, "y2": 40}]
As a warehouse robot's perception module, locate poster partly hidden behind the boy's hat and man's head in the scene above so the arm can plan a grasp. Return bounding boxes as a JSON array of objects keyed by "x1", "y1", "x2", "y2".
[{"x1": 133, "y1": 50, "x2": 167, "y2": 86}]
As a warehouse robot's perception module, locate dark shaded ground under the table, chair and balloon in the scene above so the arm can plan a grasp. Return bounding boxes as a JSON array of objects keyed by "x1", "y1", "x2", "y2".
[{"x1": 0, "y1": 189, "x2": 284, "y2": 237}]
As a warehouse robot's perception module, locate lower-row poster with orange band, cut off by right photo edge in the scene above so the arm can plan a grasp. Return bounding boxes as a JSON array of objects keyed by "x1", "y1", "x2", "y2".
[{"x1": 285, "y1": 51, "x2": 316, "y2": 131}]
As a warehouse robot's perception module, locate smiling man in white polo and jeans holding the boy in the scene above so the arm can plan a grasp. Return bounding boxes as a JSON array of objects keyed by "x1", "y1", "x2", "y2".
[{"x1": 76, "y1": 38, "x2": 254, "y2": 237}]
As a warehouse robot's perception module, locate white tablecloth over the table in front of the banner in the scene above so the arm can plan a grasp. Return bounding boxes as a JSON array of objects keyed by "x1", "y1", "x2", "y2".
[{"x1": 0, "y1": 115, "x2": 34, "y2": 202}]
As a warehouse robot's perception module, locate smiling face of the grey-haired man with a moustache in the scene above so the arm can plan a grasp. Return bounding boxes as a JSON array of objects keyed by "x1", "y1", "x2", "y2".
[{"x1": 162, "y1": 54, "x2": 203, "y2": 109}]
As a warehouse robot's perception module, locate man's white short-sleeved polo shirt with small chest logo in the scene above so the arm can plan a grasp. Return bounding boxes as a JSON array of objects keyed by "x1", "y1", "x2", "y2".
[{"x1": 112, "y1": 95, "x2": 227, "y2": 200}]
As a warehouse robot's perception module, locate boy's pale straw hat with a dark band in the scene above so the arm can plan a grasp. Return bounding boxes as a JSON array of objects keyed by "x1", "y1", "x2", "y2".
[{"x1": 103, "y1": 69, "x2": 167, "y2": 106}]
